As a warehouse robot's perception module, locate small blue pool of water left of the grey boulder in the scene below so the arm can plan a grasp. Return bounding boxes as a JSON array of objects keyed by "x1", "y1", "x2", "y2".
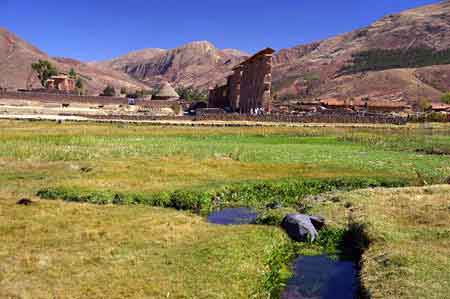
[{"x1": 208, "y1": 208, "x2": 258, "y2": 225}]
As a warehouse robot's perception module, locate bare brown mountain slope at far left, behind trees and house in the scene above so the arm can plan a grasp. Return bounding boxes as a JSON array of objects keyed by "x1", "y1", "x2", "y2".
[{"x1": 0, "y1": 28, "x2": 147, "y2": 94}]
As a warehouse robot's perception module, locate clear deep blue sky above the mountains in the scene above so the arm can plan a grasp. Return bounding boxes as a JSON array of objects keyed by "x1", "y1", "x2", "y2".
[{"x1": 0, "y1": 0, "x2": 439, "y2": 61}]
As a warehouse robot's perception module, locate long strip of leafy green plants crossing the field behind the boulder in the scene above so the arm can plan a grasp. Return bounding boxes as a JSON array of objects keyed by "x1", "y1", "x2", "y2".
[{"x1": 37, "y1": 178, "x2": 409, "y2": 213}]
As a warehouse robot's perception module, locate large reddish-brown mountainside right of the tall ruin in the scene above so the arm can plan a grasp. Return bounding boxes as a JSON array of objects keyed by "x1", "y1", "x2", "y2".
[{"x1": 273, "y1": 1, "x2": 450, "y2": 103}]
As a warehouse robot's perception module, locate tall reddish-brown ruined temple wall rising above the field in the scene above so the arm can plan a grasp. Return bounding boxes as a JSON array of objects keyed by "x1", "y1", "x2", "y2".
[{"x1": 208, "y1": 48, "x2": 275, "y2": 114}]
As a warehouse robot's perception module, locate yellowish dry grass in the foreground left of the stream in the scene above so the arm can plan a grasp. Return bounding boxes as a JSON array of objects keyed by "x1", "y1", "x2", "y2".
[{"x1": 0, "y1": 198, "x2": 286, "y2": 299}]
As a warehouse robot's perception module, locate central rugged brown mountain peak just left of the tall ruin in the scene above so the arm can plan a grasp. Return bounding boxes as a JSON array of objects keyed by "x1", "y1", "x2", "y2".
[{"x1": 93, "y1": 41, "x2": 249, "y2": 88}]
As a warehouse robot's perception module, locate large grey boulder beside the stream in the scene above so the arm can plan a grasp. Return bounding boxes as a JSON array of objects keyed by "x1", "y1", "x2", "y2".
[{"x1": 281, "y1": 214, "x2": 325, "y2": 242}]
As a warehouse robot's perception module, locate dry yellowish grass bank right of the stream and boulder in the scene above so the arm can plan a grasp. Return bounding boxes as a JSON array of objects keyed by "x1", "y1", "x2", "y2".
[{"x1": 315, "y1": 186, "x2": 450, "y2": 298}]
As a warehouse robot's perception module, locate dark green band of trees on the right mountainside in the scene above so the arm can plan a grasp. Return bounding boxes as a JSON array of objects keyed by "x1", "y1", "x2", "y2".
[{"x1": 342, "y1": 48, "x2": 450, "y2": 74}]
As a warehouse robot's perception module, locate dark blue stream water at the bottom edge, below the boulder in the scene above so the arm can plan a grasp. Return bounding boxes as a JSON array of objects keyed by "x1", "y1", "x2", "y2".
[{"x1": 281, "y1": 256, "x2": 358, "y2": 299}]
